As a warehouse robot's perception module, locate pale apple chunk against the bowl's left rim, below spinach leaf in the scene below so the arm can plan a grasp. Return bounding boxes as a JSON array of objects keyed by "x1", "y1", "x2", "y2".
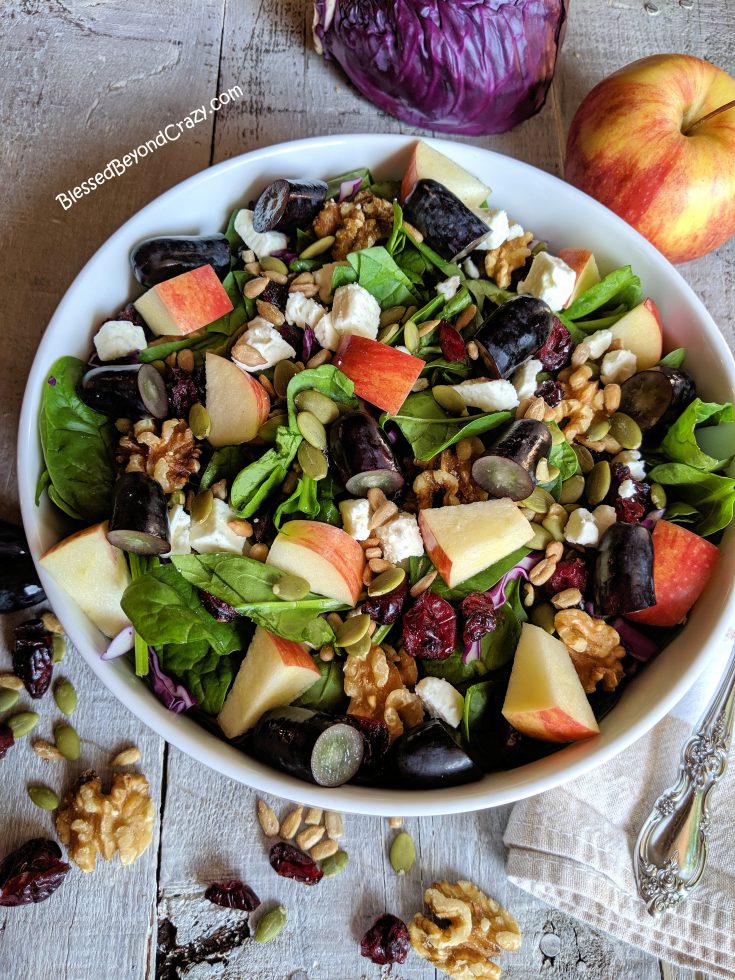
[{"x1": 41, "y1": 521, "x2": 130, "y2": 636}]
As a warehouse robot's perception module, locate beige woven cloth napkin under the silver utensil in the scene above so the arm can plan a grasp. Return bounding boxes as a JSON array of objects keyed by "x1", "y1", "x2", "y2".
[{"x1": 504, "y1": 648, "x2": 735, "y2": 978}]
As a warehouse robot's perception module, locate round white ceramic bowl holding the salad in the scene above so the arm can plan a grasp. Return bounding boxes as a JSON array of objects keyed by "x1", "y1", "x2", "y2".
[{"x1": 18, "y1": 135, "x2": 735, "y2": 816}]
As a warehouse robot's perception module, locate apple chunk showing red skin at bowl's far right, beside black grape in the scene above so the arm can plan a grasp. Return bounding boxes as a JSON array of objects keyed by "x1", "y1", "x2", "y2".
[{"x1": 625, "y1": 520, "x2": 720, "y2": 626}]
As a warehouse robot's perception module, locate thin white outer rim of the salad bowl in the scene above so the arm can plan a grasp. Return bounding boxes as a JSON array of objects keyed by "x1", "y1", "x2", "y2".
[{"x1": 17, "y1": 133, "x2": 735, "y2": 816}]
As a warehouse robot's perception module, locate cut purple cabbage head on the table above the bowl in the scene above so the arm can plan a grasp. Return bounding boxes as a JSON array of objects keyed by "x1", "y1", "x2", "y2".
[{"x1": 314, "y1": 0, "x2": 568, "y2": 136}]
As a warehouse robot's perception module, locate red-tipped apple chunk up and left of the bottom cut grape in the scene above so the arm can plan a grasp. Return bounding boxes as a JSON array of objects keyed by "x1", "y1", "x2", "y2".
[{"x1": 217, "y1": 626, "x2": 320, "y2": 738}]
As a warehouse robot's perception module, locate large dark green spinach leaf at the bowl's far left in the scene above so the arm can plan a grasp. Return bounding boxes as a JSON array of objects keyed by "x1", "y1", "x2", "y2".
[{"x1": 38, "y1": 357, "x2": 117, "y2": 521}]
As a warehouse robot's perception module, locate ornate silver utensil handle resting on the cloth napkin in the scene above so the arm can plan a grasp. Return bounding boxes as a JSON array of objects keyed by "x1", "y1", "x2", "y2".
[{"x1": 634, "y1": 648, "x2": 735, "y2": 916}]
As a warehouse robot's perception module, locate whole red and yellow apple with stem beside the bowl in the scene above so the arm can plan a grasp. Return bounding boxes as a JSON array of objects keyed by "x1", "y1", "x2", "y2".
[{"x1": 564, "y1": 54, "x2": 735, "y2": 262}]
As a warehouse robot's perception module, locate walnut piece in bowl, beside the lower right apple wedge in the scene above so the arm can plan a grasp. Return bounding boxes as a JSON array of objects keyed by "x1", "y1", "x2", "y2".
[{"x1": 554, "y1": 609, "x2": 625, "y2": 694}]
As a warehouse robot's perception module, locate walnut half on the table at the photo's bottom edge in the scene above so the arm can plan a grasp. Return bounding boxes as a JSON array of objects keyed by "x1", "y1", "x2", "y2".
[{"x1": 408, "y1": 881, "x2": 521, "y2": 980}]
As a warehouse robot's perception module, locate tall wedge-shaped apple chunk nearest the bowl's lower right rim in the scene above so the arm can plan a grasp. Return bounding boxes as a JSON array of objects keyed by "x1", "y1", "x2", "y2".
[{"x1": 503, "y1": 623, "x2": 600, "y2": 742}]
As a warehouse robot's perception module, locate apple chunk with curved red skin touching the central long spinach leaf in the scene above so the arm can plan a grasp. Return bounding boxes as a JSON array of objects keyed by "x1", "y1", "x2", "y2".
[{"x1": 266, "y1": 521, "x2": 365, "y2": 606}]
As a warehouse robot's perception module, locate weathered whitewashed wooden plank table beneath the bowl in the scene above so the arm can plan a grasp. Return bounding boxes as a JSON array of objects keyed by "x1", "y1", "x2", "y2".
[{"x1": 0, "y1": 0, "x2": 735, "y2": 980}]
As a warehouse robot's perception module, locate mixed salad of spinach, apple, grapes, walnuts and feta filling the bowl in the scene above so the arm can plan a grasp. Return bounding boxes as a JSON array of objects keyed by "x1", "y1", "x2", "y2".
[{"x1": 31, "y1": 143, "x2": 735, "y2": 789}]
